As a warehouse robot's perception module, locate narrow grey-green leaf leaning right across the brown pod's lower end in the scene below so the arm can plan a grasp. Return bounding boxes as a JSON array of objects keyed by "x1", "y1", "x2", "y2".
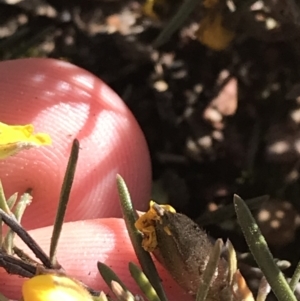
[{"x1": 196, "y1": 239, "x2": 223, "y2": 301}]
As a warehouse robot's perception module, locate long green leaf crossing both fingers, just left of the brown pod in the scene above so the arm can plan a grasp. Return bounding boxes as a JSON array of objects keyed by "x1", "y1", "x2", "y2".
[{"x1": 117, "y1": 175, "x2": 167, "y2": 301}]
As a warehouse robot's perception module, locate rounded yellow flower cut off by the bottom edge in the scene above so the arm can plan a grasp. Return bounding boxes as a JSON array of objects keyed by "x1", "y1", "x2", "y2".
[{"x1": 22, "y1": 274, "x2": 93, "y2": 301}]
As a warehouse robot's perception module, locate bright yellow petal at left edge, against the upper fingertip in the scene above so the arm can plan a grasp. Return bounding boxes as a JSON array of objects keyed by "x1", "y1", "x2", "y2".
[{"x1": 0, "y1": 122, "x2": 51, "y2": 159}]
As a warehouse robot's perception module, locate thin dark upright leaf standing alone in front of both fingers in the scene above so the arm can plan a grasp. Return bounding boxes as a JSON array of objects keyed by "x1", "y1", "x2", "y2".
[{"x1": 50, "y1": 139, "x2": 79, "y2": 266}]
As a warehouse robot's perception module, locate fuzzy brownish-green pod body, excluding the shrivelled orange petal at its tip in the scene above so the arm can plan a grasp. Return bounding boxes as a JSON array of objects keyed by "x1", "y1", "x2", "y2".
[{"x1": 153, "y1": 205, "x2": 227, "y2": 295}]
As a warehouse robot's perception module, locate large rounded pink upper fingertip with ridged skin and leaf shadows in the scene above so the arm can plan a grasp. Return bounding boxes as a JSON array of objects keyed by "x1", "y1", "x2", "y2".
[{"x1": 0, "y1": 59, "x2": 151, "y2": 229}]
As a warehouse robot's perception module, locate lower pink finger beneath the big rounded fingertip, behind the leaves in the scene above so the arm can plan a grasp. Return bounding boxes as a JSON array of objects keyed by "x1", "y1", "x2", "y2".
[{"x1": 0, "y1": 218, "x2": 192, "y2": 301}]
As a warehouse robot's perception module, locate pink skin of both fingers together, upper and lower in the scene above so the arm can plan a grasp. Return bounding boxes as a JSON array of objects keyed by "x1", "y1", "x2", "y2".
[{"x1": 0, "y1": 59, "x2": 190, "y2": 300}]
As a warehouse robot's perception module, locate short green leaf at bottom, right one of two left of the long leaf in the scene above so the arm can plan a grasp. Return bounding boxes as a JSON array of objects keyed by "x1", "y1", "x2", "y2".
[{"x1": 129, "y1": 262, "x2": 160, "y2": 301}]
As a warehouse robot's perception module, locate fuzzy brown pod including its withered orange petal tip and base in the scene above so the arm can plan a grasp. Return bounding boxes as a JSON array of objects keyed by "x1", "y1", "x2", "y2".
[{"x1": 136, "y1": 202, "x2": 254, "y2": 301}]
